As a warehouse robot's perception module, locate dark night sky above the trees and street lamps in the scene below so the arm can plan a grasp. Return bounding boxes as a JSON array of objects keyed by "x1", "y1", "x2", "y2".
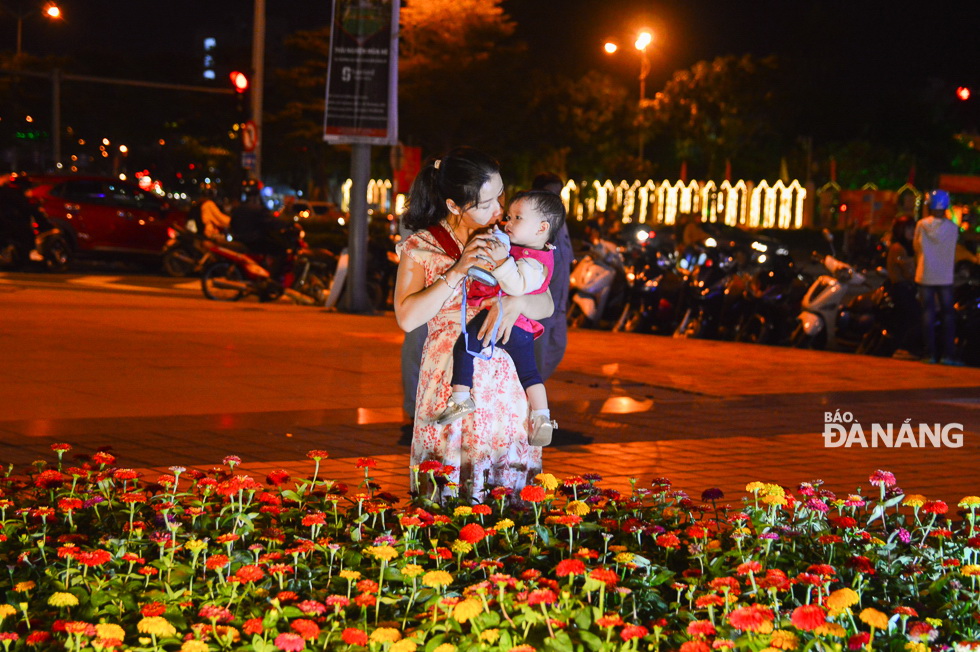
[{"x1": 15, "y1": 0, "x2": 980, "y2": 139}]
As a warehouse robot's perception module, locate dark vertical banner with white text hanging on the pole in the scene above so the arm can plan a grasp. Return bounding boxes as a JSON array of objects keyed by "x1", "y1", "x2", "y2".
[{"x1": 323, "y1": 0, "x2": 399, "y2": 145}]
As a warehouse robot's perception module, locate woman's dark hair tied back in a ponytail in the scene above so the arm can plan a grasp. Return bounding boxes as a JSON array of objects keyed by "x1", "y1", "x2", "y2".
[{"x1": 402, "y1": 147, "x2": 500, "y2": 231}]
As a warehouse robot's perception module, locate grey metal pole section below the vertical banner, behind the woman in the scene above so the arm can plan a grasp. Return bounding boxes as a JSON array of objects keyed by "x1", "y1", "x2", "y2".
[{"x1": 344, "y1": 143, "x2": 373, "y2": 313}]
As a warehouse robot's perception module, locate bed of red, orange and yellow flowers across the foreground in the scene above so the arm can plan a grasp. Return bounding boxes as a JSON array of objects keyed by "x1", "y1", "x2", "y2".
[{"x1": 0, "y1": 444, "x2": 980, "y2": 652}]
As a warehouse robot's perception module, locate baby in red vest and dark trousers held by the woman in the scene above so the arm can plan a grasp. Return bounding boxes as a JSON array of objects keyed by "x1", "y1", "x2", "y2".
[{"x1": 436, "y1": 190, "x2": 565, "y2": 446}]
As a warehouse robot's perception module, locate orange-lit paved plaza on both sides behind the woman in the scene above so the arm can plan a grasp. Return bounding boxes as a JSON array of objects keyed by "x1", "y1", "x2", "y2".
[{"x1": 0, "y1": 283, "x2": 980, "y2": 504}]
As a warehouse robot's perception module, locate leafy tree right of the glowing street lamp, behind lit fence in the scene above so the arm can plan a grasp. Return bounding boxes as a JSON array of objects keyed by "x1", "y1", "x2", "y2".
[{"x1": 644, "y1": 55, "x2": 781, "y2": 177}]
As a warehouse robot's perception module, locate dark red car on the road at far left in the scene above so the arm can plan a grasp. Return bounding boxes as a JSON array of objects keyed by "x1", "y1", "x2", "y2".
[{"x1": 30, "y1": 175, "x2": 187, "y2": 264}]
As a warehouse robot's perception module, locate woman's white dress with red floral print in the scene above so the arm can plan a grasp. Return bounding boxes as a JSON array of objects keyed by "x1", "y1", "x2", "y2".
[{"x1": 399, "y1": 224, "x2": 541, "y2": 501}]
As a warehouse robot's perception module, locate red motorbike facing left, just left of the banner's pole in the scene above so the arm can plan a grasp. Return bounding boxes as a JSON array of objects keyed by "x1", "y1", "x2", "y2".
[{"x1": 201, "y1": 224, "x2": 337, "y2": 306}]
